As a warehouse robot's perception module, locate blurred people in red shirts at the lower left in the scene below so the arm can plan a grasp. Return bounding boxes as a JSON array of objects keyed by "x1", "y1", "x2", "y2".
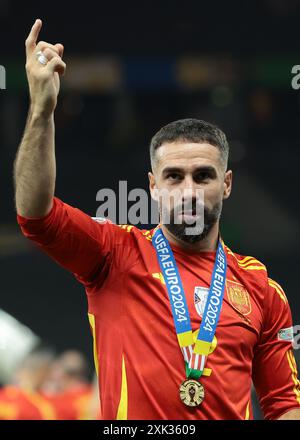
[{"x1": 0, "y1": 347, "x2": 100, "y2": 420}]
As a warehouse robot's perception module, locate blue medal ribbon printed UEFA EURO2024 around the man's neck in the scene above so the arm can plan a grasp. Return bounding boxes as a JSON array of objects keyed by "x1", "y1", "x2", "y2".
[{"x1": 152, "y1": 228, "x2": 227, "y2": 379}]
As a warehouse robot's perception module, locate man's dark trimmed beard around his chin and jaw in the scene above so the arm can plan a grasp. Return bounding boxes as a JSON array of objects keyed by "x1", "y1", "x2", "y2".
[{"x1": 165, "y1": 202, "x2": 222, "y2": 244}]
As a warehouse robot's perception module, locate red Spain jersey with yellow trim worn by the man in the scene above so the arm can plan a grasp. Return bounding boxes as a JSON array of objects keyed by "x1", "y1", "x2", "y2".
[{"x1": 18, "y1": 198, "x2": 300, "y2": 420}]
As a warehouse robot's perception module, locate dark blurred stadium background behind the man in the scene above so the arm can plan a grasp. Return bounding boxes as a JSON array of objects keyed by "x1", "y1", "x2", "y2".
[{"x1": 0, "y1": 0, "x2": 300, "y2": 420}]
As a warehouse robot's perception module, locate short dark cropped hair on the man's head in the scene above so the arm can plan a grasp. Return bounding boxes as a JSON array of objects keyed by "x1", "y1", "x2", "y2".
[{"x1": 150, "y1": 118, "x2": 229, "y2": 169}]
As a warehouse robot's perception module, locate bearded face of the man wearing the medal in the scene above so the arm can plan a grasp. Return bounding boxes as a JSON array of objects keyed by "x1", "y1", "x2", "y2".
[{"x1": 149, "y1": 141, "x2": 232, "y2": 243}]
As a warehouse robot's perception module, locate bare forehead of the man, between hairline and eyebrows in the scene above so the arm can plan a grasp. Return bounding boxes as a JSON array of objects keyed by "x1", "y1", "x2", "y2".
[{"x1": 156, "y1": 142, "x2": 220, "y2": 167}]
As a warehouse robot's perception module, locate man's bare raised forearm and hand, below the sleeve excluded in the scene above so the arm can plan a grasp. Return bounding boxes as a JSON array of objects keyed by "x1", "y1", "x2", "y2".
[{"x1": 14, "y1": 20, "x2": 66, "y2": 217}]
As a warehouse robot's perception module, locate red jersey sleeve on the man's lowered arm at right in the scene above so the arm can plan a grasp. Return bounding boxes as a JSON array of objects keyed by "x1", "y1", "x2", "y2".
[{"x1": 252, "y1": 279, "x2": 300, "y2": 419}]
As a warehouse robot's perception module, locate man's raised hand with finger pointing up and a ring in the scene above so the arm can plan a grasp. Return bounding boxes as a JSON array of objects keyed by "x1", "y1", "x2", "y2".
[{"x1": 25, "y1": 19, "x2": 66, "y2": 117}]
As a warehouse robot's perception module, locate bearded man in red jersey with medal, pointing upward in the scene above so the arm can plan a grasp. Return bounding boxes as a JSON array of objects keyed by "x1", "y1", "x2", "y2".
[{"x1": 15, "y1": 20, "x2": 300, "y2": 419}]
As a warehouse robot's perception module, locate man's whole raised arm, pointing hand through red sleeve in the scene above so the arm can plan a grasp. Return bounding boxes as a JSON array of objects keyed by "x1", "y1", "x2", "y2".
[{"x1": 14, "y1": 20, "x2": 129, "y2": 289}]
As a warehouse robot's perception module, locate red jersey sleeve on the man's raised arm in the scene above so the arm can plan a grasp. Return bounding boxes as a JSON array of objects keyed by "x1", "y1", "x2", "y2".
[{"x1": 17, "y1": 197, "x2": 124, "y2": 285}]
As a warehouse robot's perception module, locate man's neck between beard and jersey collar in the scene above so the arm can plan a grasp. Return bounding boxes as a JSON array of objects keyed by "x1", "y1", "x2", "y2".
[{"x1": 162, "y1": 222, "x2": 219, "y2": 253}]
